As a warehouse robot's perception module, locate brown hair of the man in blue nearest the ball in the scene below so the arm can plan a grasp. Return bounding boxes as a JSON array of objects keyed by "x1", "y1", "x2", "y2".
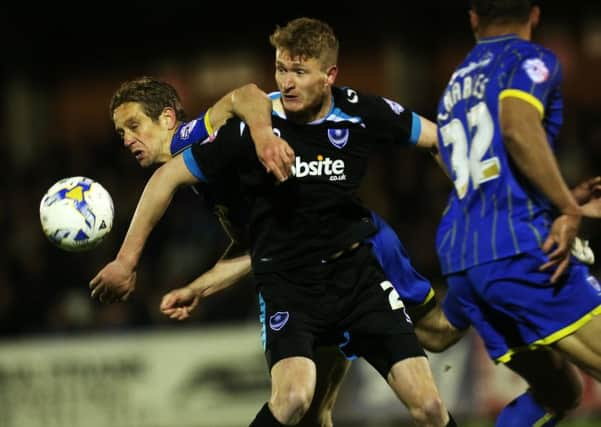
[{"x1": 109, "y1": 77, "x2": 186, "y2": 121}]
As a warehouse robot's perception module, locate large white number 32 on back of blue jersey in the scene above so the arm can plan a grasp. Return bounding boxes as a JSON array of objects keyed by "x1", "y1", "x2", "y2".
[{"x1": 440, "y1": 102, "x2": 501, "y2": 199}]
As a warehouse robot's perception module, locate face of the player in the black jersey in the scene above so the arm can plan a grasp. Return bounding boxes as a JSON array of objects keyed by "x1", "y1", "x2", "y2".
[{"x1": 275, "y1": 49, "x2": 330, "y2": 121}]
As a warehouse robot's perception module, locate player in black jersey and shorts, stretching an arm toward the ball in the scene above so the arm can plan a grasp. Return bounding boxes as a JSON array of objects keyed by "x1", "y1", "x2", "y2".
[{"x1": 93, "y1": 18, "x2": 455, "y2": 426}]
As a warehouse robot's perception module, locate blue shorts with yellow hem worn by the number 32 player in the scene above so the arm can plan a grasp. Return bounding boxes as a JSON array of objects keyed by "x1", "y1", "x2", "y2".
[{"x1": 443, "y1": 249, "x2": 601, "y2": 363}]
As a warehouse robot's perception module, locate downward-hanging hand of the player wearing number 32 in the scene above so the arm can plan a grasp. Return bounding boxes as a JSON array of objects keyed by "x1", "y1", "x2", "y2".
[{"x1": 540, "y1": 215, "x2": 581, "y2": 283}]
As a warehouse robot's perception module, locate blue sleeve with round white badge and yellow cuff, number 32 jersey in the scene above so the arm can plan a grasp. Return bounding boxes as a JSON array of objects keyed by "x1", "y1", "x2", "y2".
[{"x1": 499, "y1": 47, "x2": 562, "y2": 117}]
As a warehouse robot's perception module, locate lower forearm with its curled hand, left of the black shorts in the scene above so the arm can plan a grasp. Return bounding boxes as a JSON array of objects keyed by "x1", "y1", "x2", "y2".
[{"x1": 160, "y1": 255, "x2": 251, "y2": 320}]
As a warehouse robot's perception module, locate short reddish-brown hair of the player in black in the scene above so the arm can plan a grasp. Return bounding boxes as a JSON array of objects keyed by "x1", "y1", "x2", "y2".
[{"x1": 269, "y1": 18, "x2": 338, "y2": 66}]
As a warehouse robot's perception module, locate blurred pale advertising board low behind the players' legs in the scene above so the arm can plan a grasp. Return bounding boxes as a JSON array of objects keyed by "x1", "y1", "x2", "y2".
[{"x1": 0, "y1": 323, "x2": 601, "y2": 427}]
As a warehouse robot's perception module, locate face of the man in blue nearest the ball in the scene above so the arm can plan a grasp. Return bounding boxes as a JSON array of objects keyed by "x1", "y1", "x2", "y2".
[{"x1": 113, "y1": 102, "x2": 170, "y2": 167}]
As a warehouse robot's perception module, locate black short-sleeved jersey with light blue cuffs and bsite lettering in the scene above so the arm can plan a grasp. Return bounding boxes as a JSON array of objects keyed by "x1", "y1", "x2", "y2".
[{"x1": 184, "y1": 87, "x2": 421, "y2": 273}]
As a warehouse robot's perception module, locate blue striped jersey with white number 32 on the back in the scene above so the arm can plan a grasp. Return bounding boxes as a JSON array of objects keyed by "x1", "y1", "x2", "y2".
[{"x1": 436, "y1": 35, "x2": 563, "y2": 274}]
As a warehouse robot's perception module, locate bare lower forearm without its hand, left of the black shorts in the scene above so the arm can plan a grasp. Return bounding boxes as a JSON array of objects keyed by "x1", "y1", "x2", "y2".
[{"x1": 188, "y1": 255, "x2": 251, "y2": 298}]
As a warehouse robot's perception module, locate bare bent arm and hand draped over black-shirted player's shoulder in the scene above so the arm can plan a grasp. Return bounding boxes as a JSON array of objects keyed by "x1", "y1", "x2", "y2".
[{"x1": 209, "y1": 83, "x2": 294, "y2": 181}]
